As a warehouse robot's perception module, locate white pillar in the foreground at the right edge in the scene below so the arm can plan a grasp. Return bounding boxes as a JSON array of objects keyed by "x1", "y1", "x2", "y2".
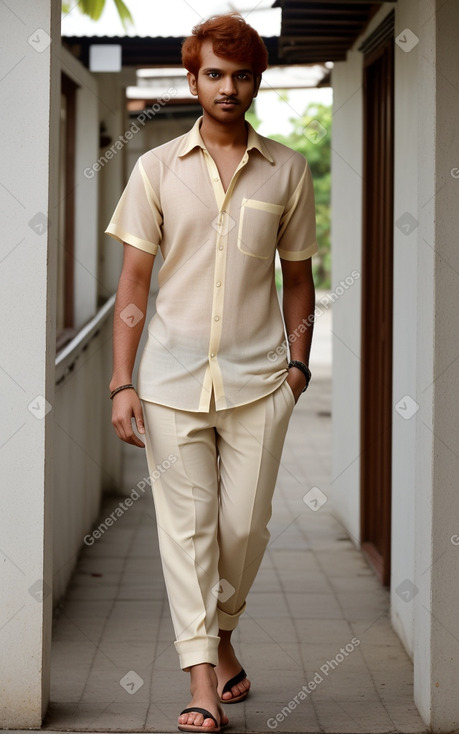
[{"x1": 413, "y1": 0, "x2": 459, "y2": 732}]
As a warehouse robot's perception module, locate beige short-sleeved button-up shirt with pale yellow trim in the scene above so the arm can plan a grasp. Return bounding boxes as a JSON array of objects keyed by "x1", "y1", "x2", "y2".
[{"x1": 106, "y1": 118, "x2": 317, "y2": 411}]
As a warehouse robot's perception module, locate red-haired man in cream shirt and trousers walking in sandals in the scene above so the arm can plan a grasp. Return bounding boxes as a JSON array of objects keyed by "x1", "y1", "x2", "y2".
[{"x1": 107, "y1": 15, "x2": 317, "y2": 732}]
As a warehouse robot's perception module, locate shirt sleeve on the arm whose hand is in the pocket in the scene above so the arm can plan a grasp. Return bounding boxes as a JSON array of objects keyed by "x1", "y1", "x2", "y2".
[{"x1": 277, "y1": 163, "x2": 318, "y2": 261}]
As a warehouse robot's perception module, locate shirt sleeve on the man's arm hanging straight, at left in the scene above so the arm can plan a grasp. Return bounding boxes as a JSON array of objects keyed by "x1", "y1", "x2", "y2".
[{"x1": 105, "y1": 158, "x2": 163, "y2": 255}]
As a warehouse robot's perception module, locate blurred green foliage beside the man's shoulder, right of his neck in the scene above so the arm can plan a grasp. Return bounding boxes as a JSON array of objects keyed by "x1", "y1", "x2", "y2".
[{"x1": 269, "y1": 103, "x2": 332, "y2": 288}]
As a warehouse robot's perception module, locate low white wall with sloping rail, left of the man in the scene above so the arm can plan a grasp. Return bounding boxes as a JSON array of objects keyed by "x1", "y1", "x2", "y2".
[{"x1": 53, "y1": 296, "x2": 121, "y2": 603}]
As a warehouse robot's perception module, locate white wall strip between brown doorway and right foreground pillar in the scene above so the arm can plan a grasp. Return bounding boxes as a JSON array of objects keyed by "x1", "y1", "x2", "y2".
[{"x1": 391, "y1": 0, "x2": 420, "y2": 656}]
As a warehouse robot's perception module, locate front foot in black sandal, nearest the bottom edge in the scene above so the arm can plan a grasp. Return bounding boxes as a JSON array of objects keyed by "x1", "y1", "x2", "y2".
[{"x1": 178, "y1": 663, "x2": 228, "y2": 731}]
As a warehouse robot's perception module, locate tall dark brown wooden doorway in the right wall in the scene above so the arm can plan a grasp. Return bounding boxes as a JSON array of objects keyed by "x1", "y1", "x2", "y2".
[{"x1": 360, "y1": 16, "x2": 394, "y2": 586}]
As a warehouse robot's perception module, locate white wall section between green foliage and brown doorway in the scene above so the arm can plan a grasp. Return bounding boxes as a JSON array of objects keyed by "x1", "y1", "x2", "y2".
[{"x1": 330, "y1": 51, "x2": 362, "y2": 545}]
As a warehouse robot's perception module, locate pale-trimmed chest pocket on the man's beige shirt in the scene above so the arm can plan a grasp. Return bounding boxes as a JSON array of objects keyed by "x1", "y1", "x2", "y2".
[{"x1": 237, "y1": 199, "x2": 284, "y2": 260}]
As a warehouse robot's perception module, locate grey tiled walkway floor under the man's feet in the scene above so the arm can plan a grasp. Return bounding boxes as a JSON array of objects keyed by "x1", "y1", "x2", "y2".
[{"x1": 44, "y1": 302, "x2": 426, "y2": 734}]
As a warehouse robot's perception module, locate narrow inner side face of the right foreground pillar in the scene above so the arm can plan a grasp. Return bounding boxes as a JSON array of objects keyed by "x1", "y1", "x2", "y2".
[{"x1": 413, "y1": 2, "x2": 436, "y2": 730}]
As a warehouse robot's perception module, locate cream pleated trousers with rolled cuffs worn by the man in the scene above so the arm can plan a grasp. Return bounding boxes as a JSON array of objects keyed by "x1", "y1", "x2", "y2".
[{"x1": 143, "y1": 381, "x2": 295, "y2": 670}]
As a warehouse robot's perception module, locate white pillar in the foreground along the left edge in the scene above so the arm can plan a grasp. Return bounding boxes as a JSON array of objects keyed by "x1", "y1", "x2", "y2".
[{"x1": 0, "y1": 0, "x2": 60, "y2": 728}]
